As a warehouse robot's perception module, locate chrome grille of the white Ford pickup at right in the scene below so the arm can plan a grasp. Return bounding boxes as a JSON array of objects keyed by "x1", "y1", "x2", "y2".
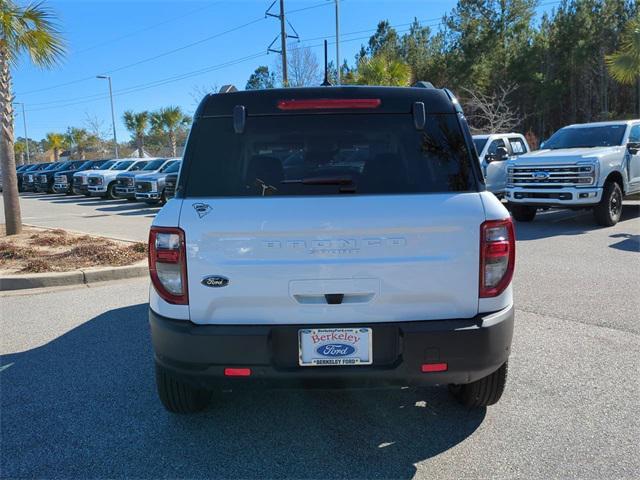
[{"x1": 507, "y1": 165, "x2": 596, "y2": 188}]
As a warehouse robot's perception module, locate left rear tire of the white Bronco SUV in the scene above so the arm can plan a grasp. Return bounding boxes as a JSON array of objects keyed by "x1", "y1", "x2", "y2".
[{"x1": 156, "y1": 365, "x2": 211, "y2": 413}]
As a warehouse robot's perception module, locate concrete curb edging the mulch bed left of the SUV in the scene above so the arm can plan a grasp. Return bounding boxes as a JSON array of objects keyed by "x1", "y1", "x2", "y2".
[{"x1": 0, "y1": 261, "x2": 149, "y2": 292}]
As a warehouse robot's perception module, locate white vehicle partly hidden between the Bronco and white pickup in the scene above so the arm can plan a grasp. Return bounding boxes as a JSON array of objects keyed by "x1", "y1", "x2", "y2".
[{"x1": 473, "y1": 133, "x2": 531, "y2": 198}]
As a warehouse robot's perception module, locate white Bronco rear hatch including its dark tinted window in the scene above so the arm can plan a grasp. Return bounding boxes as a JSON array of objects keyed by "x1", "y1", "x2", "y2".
[{"x1": 179, "y1": 110, "x2": 485, "y2": 324}]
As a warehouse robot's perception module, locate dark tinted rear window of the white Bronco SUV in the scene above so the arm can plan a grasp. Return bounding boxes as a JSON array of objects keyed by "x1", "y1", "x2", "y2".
[{"x1": 181, "y1": 114, "x2": 475, "y2": 197}]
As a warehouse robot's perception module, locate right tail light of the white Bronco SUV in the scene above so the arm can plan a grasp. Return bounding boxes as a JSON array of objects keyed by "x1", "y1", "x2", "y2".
[{"x1": 480, "y1": 218, "x2": 516, "y2": 298}]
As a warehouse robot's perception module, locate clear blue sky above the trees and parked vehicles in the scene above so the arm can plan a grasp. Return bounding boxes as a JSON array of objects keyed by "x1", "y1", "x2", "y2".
[{"x1": 13, "y1": 0, "x2": 549, "y2": 142}]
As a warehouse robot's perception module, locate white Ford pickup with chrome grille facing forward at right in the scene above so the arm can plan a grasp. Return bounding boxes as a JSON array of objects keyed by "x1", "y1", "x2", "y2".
[{"x1": 506, "y1": 120, "x2": 640, "y2": 226}]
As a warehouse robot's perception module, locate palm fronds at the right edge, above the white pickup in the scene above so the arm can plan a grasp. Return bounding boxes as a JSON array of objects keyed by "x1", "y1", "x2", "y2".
[{"x1": 606, "y1": 17, "x2": 640, "y2": 113}]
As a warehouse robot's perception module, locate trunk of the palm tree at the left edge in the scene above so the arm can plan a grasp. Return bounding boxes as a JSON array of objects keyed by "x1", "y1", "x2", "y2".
[{"x1": 0, "y1": 47, "x2": 22, "y2": 235}]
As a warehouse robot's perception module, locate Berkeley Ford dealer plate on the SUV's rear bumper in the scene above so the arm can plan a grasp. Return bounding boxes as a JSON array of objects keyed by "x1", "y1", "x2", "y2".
[{"x1": 298, "y1": 328, "x2": 373, "y2": 367}]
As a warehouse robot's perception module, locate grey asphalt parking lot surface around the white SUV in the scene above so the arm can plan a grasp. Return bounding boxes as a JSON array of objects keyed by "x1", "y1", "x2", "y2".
[{"x1": 0, "y1": 196, "x2": 640, "y2": 479}]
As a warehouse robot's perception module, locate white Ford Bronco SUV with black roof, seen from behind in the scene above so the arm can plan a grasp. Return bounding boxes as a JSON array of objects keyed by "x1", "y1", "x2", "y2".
[{"x1": 149, "y1": 86, "x2": 515, "y2": 413}]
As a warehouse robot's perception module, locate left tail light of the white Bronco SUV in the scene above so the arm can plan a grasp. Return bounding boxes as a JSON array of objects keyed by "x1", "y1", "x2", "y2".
[{"x1": 149, "y1": 227, "x2": 189, "y2": 305}]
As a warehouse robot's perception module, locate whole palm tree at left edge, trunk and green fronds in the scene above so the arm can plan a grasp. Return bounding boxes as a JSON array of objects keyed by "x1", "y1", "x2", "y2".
[{"x1": 0, "y1": 0, "x2": 64, "y2": 235}]
